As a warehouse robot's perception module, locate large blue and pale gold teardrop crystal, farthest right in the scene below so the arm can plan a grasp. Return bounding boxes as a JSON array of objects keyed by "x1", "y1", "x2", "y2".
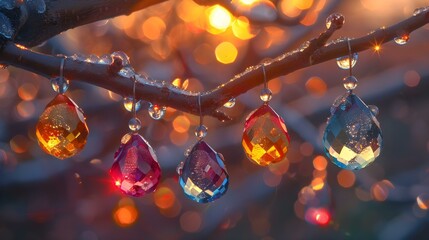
[{"x1": 323, "y1": 94, "x2": 383, "y2": 170}]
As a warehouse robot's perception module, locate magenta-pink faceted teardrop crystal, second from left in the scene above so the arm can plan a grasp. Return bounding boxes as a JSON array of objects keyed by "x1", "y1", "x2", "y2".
[{"x1": 110, "y1": 133, "x2": 161, "y2": 197}]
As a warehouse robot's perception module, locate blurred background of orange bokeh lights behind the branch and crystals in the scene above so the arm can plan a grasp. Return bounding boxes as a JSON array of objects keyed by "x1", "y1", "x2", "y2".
[{"x1": 0, "y1": 0, "x2": 429, "y2": 240}]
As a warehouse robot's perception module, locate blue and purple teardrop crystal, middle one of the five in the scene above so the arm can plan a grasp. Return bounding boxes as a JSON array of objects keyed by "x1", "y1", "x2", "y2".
[{"x1": 179, "y1": 140, "x2": 229, "y2": 203}]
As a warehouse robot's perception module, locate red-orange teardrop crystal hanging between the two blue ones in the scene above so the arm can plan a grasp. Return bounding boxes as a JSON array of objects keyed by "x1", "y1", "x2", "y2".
[{"x1": 241, "y1": 104, "x2": 290, "y2": 166}]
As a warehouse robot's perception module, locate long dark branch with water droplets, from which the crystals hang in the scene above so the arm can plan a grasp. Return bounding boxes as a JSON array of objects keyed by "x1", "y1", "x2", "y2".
[{"x1": 0, "y1": 9, "x2": 429, "y2": 121}]
